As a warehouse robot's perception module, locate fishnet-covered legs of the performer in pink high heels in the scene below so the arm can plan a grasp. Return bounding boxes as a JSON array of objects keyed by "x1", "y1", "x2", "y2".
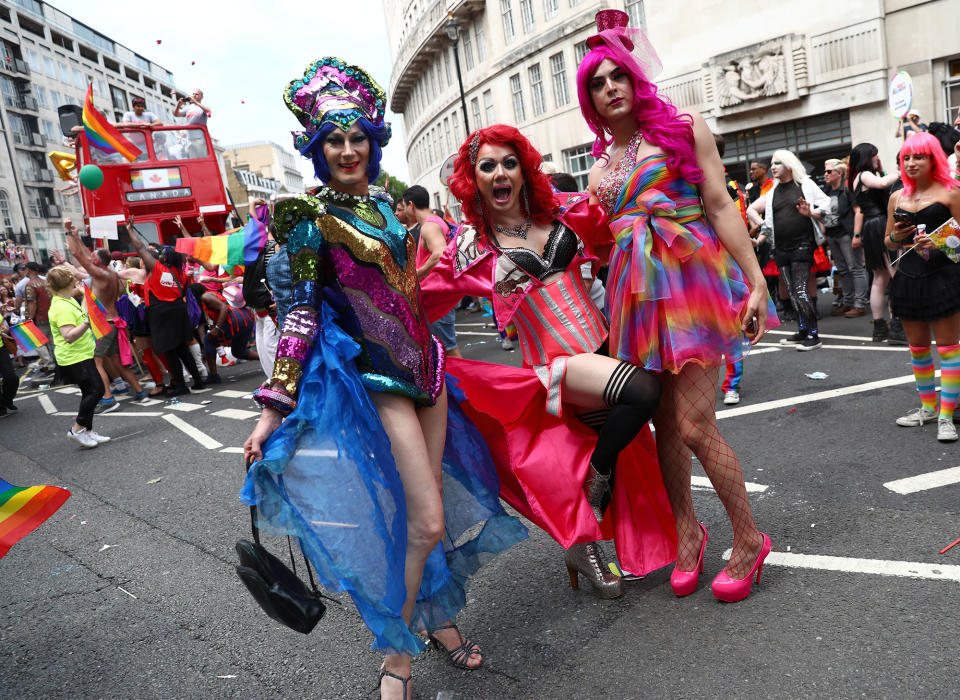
[{"x1": 654, "y1": 363, "x2": 763, "y2": 579}]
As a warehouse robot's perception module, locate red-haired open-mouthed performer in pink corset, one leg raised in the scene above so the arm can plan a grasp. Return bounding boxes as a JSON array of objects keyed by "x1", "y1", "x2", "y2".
[{"x1": 421, "y1": 125, "x2": 675, "y2": 598}]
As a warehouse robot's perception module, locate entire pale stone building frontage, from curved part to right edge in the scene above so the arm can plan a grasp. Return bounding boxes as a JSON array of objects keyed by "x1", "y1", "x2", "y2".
[{"x1": 383, "y1": 0, "x2": 960, "y2": 204}]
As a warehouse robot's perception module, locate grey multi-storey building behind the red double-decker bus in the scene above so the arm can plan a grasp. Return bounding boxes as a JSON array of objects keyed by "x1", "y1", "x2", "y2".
[{"x1": 0, "y1": 0, "x2": 184, "y2": 260}]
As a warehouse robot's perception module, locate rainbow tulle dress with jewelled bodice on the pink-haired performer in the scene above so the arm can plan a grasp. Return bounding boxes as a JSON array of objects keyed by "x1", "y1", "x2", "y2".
[{"x1": 597, "y1": 133, "x2": 777, "y2": 372}]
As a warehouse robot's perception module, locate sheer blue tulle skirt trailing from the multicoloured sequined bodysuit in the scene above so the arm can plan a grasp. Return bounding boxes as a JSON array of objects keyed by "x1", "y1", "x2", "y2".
[{"x1": 240, "y1": 305, "x2": 527, "y2": 655}]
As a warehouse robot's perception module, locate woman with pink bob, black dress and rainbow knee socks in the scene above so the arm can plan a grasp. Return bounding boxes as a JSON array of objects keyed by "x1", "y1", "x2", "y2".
[{"x1": 883, "y1": 132, "x2": 960, "y2": 442}]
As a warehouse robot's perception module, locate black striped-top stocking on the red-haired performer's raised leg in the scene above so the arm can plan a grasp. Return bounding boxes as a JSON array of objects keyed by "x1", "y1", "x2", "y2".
[{"x1": 591, "y1": 362, "x2": 660, "y2": 474}]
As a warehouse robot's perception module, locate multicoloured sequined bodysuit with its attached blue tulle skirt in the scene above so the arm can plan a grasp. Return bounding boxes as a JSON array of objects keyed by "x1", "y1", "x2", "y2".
[{"x1": 241, "y1": 190, "x2": 526, "y2": 654}]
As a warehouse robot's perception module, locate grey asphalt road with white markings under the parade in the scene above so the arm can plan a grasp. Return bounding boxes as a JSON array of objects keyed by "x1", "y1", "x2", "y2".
[{"x1": 0, "y1": 299, "x2": 960, "y2": 700}]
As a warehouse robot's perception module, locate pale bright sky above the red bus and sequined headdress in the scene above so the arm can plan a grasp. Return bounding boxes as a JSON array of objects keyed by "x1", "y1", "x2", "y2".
[{"x1": 50, "y1": 0, "x2": 408, "y2": 181}]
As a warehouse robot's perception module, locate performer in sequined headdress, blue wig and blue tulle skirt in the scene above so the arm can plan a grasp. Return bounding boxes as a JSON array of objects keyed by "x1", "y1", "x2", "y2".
[{"x1": 242, "y1": 57, "x2": 526, "y2": 698}]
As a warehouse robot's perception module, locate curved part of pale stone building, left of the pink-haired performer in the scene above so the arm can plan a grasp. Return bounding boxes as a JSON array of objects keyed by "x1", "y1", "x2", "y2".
[{"x1": 383, "y1": 0, "x2": 632, "y2": 209}]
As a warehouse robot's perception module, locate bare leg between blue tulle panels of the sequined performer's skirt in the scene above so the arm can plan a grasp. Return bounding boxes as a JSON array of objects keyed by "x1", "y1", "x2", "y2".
[{"x1": 370, "y1": 392, "x2": 447, "y2": 697}]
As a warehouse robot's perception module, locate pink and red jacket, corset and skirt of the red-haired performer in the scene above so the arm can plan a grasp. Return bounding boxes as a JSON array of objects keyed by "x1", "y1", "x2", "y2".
[{"x1": 421, "y1": 195, "x2": 676, "y2": 574}]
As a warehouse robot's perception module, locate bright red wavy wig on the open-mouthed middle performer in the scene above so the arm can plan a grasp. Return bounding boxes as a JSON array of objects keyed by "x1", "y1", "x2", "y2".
[{"x1": 450, "y1": 124, "x2": 557, "y2": 234}]
